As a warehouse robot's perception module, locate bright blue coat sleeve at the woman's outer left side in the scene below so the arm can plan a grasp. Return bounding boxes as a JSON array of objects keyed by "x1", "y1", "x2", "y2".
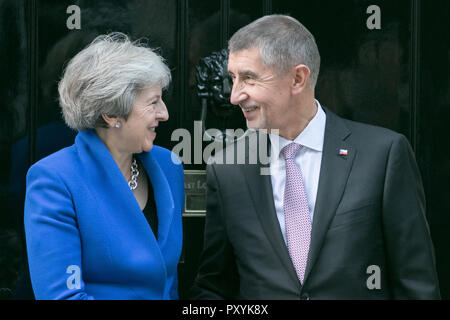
[{"x1": 24, "y1": 163, "x2": 93, "y2": 300}]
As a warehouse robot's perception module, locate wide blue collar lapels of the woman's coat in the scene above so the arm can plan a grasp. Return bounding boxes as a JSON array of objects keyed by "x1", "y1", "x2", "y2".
[{"x1": 75, "y1": 129, "x2": 175, "y2": 247}]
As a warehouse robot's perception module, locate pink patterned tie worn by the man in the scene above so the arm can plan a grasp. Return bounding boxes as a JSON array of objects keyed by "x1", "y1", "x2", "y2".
[{"x1": 281, "y1": 142, "x2": 311, "y2": 283}]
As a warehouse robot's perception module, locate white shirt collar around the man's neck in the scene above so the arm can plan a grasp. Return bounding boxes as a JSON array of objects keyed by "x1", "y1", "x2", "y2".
[{"x1": 269, "y1": 100, "x2": 326, "y2": 158}]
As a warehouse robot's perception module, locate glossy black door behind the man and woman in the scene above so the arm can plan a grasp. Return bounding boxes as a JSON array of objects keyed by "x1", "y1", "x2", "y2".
[{"x1": 0, "y1": 0, "x2": 450, "y2": 299}]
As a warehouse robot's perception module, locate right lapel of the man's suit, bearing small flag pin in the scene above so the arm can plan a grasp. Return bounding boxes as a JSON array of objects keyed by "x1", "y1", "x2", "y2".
[{"x1": 304, "y1": 108, "x2": 356, "y2": 281}]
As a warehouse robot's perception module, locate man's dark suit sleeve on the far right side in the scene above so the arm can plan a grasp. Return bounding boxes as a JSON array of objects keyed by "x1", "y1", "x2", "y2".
[{"x1": 383, "y1": 135, "x2": 440, "y2": 299}]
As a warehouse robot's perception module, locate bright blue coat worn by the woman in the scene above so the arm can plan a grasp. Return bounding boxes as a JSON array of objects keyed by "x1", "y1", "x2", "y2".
[{"x1": 25, "y1": 130, "x2": 185, "y2": 299}]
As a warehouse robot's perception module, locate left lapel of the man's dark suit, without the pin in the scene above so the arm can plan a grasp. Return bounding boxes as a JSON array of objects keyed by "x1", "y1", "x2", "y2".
[{"x1": 239, "y1": 133, "x2": 300, "y2": 285}]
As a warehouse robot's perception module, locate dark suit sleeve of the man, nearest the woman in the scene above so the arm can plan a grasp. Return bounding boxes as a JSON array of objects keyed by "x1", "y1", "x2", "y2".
[{"x1": 190, "y1": 165, "x2": 239, "y2": 299}]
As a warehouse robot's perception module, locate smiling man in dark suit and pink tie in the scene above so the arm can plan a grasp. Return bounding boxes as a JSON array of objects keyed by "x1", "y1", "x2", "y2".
[{"x1": 192, "y1": 15, "x2": 440, "y2": 299}]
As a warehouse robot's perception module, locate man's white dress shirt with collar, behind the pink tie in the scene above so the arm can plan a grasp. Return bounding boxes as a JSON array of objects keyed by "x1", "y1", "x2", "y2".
[{"x1": 269, "y1": 100, "x2": 326, "y2": 242}]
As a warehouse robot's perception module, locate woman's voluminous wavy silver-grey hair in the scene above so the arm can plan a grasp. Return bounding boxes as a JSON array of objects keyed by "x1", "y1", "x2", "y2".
[{"x1": 58, "y1": 32, "x2": 171, "y2": 130}]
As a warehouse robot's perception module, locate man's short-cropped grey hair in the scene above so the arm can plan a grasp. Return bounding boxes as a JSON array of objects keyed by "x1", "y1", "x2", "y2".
[{"x1": 228, "y1": 14, "x2": 320, "y2": 89}]
